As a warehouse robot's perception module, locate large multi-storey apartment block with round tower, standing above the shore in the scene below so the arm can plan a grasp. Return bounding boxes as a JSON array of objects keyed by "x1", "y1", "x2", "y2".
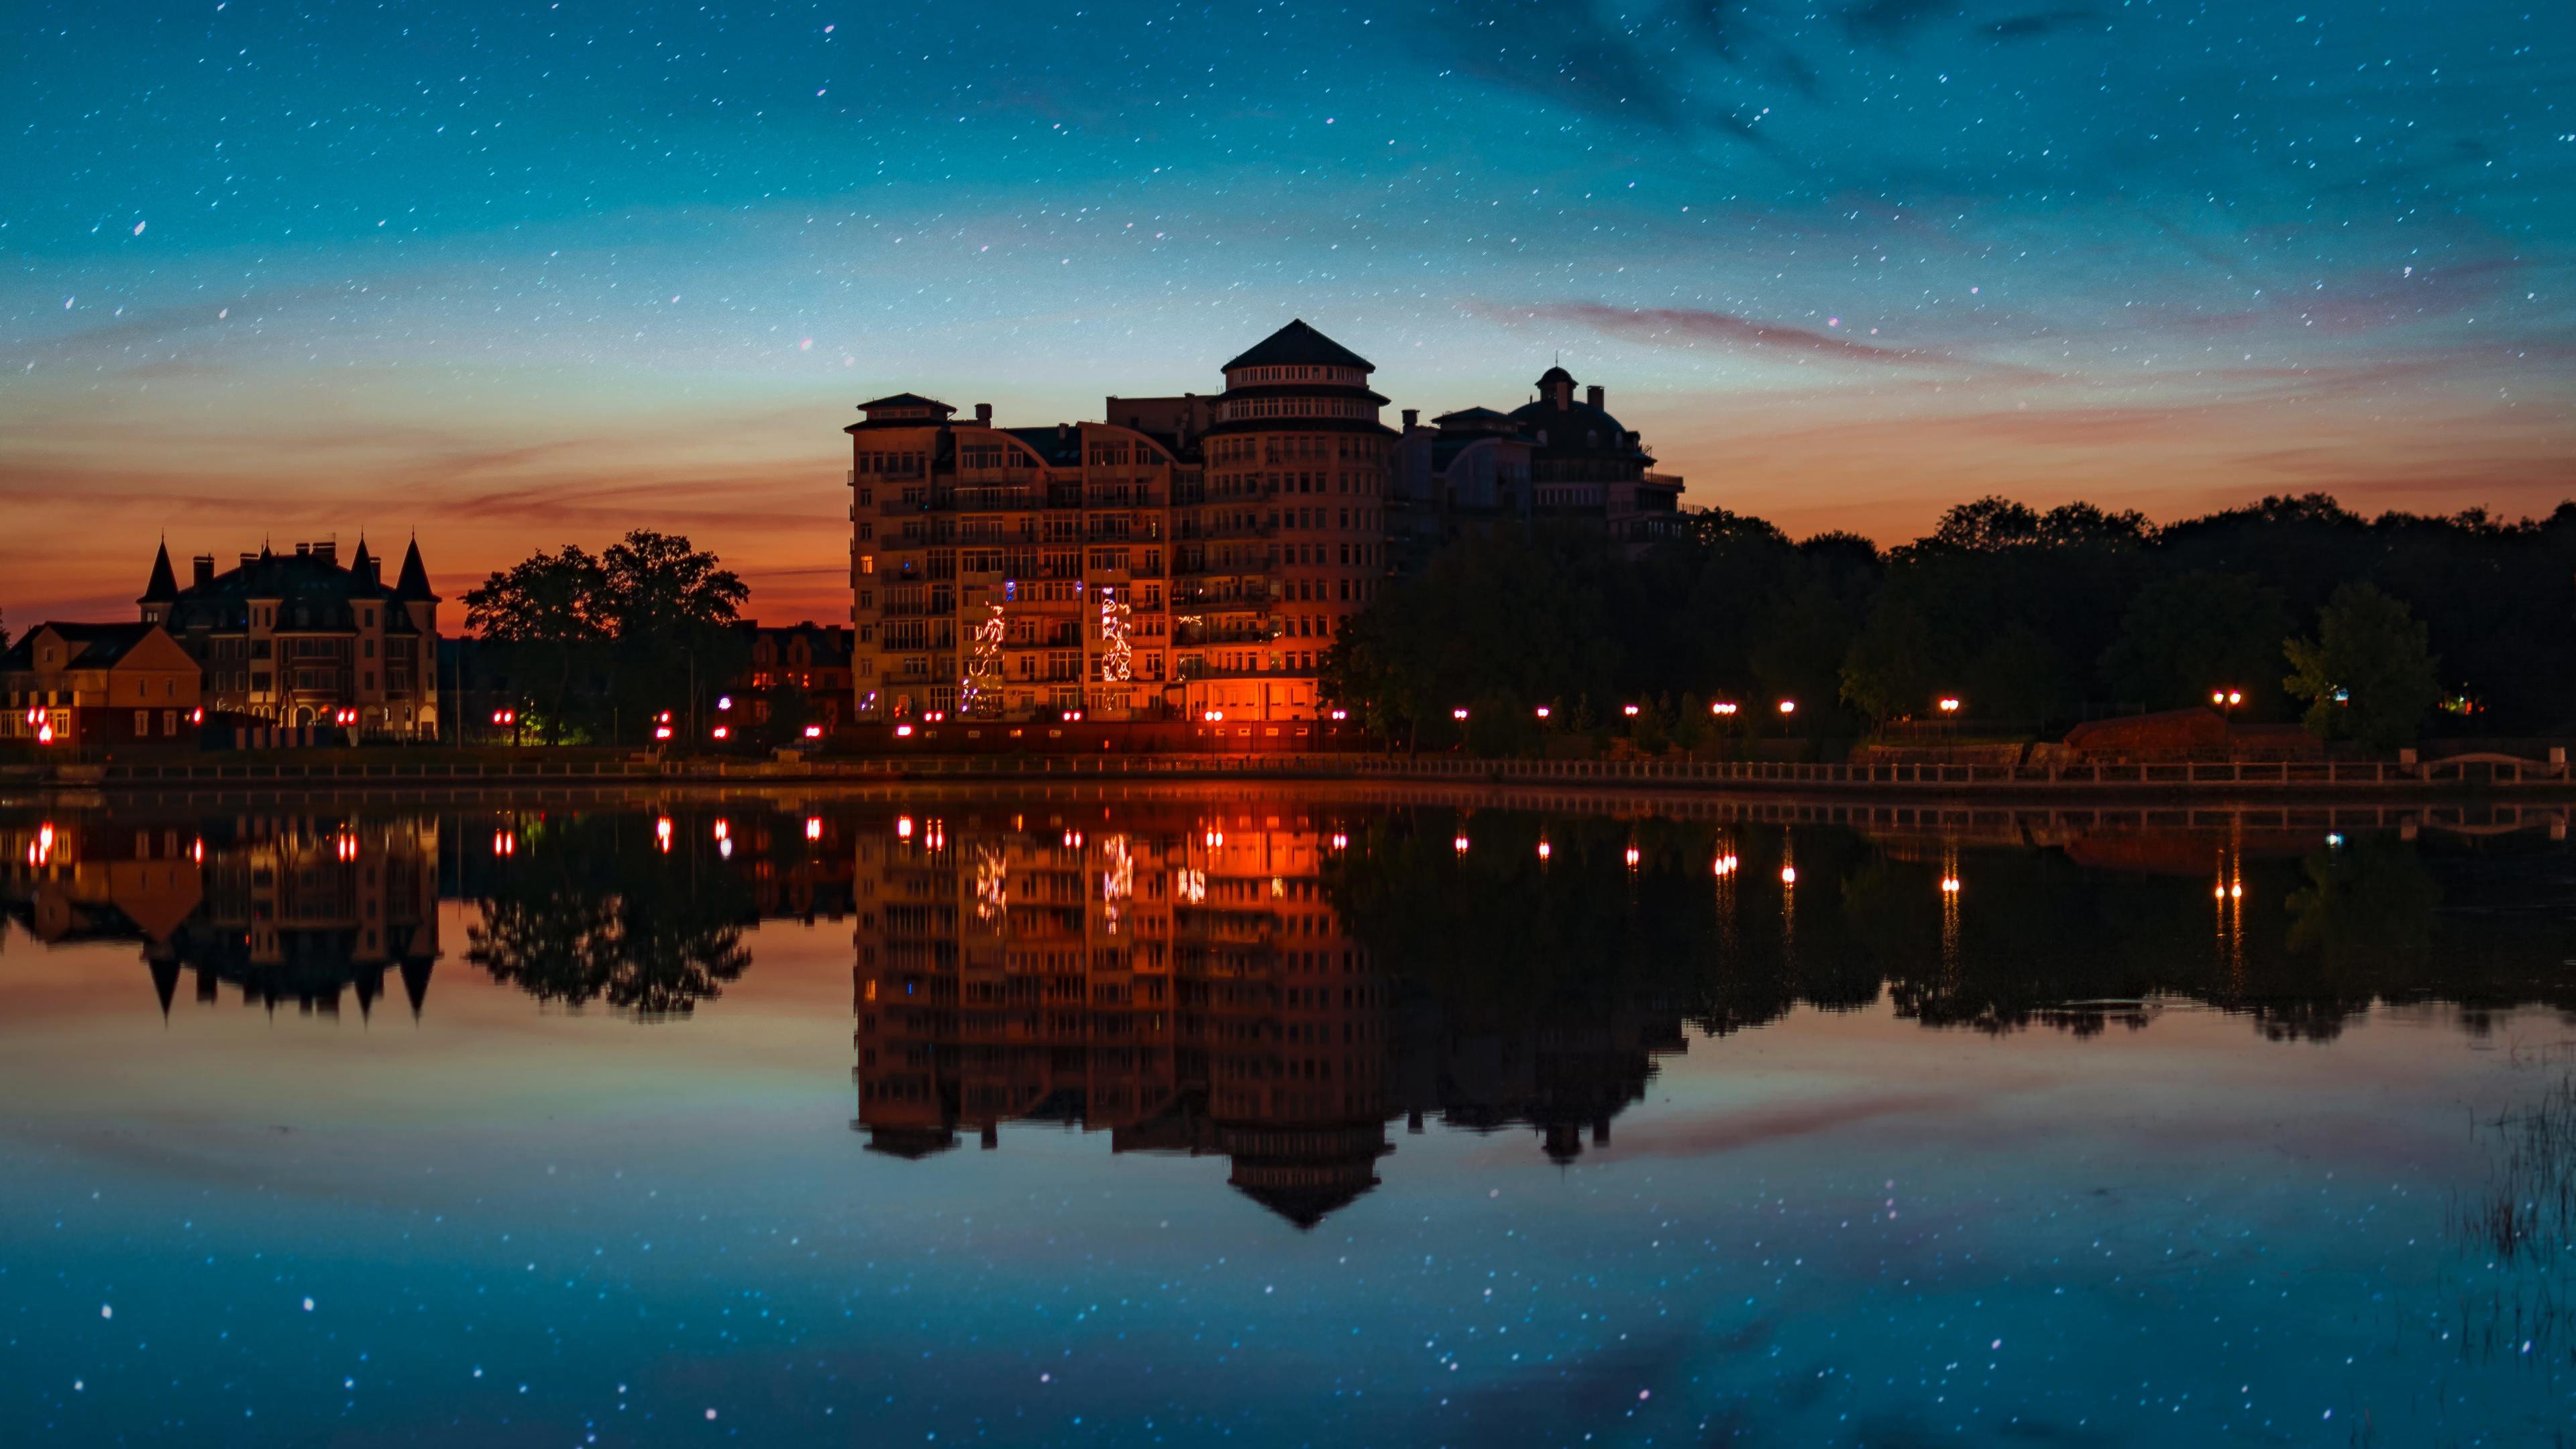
[{"x1": 845, "y1": 320, "x2": 1682, "y2": 724}]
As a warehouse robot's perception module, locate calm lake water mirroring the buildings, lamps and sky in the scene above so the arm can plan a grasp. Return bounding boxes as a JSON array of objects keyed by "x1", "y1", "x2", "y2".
[{"x1": 0, "y1": 794, "x2": 2576, "y2": 1446}]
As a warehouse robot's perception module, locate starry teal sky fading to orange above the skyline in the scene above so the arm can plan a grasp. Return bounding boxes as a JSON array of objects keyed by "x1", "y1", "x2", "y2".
[{"x1": 0, "y1": 0, "x2": 2576, "y2": 627}]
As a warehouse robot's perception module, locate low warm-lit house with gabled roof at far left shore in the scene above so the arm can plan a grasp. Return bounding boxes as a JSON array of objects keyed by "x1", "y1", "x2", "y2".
[{"x1": 0, "y1": 624, "x2": 203, "y2": 750}]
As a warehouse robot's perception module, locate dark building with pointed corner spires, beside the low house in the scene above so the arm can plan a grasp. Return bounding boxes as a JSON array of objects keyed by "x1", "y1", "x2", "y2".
[{"x1": 137, "y1": 539, "x2": 441, "y2": 737}]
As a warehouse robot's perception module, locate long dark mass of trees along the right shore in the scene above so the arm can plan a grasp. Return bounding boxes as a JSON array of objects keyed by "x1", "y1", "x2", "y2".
[{"x1": 1324, "y1": 495, "x2": 2576, "y2": 753}]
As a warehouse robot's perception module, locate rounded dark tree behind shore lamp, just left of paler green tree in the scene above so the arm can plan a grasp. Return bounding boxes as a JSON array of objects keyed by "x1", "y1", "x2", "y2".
[{"x1": 2102, "y1": 570, "x2": 2290, "y2": 712}]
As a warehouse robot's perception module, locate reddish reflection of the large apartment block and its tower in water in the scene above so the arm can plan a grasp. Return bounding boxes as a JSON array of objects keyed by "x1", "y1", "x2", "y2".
[{"x1": 855, "y1": 810, "x2": 1389, "y2": 1227}]
